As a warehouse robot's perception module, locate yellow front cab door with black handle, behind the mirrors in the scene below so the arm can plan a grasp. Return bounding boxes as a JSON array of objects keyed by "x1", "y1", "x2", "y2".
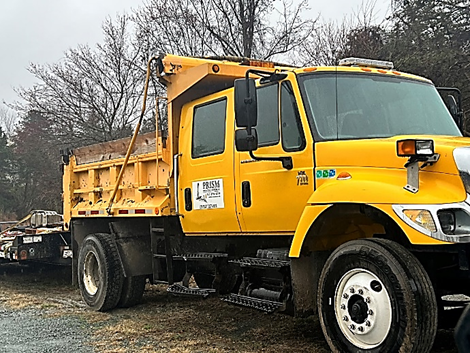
[{"x1": 235, "y1": 74, "x2": 314, "y2": 234}]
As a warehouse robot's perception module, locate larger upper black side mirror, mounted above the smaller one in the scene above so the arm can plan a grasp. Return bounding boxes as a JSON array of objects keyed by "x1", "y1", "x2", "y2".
[{"x1": 234, "y1": 78, "x2": 258, "y2": 128}]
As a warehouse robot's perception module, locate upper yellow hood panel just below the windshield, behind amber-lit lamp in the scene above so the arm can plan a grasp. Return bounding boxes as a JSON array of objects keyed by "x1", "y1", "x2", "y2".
[{"x1": 315, "y1": 135, "x2": 470, "y2": 175}]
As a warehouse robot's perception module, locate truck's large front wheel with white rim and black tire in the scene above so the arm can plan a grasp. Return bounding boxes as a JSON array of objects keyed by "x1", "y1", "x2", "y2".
[{"x1": 318, "y1": 239, "x2": 437, "y2": 353}]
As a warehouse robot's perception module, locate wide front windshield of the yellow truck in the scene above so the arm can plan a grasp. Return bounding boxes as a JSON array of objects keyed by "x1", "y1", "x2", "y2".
[{"x1": 299, "y1": 72, "x2": 461, "y2": 140}]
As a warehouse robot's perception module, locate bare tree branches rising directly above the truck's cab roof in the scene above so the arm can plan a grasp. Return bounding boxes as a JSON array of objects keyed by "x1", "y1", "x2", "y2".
[{"x1": 134, "y1": 0, "x2": 315, "y2": 59}]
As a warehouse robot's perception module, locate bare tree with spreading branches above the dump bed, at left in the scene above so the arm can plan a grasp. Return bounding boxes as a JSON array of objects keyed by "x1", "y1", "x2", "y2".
[{"x1": 13, "y1": 16, "x2": 149, "y2": 145}]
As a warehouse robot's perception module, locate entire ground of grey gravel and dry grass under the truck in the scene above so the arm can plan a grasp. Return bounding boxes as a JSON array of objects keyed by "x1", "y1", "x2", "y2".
[{"x1": 0, "y1": 264, "x2": 457, "y2": 353}]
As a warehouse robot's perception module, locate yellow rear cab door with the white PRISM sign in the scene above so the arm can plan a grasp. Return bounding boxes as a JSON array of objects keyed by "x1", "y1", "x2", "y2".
[{"x1": 178, "y1": 93, "x2": 240, "y2": 234}]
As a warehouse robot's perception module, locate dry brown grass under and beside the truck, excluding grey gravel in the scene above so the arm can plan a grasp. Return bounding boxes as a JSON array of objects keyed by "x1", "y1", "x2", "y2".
[{"x1": 0, "y1": 265, "x2": 456, "y2": 353}]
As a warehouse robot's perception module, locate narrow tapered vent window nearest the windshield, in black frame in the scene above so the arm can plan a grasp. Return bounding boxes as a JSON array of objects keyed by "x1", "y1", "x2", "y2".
[{"x1": 281, "y1": 81, "x2": 305, "y2": 151}]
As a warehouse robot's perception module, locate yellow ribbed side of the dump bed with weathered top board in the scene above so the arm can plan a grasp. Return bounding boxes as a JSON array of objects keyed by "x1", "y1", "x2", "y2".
[{"x1": 64, "y1": 132, "x2": 170, "y2": 223}]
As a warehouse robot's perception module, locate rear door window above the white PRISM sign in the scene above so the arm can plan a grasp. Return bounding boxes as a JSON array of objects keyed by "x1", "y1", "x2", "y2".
[{"x1": 192, "y1": 99, "x2": 227, "y2": 158}]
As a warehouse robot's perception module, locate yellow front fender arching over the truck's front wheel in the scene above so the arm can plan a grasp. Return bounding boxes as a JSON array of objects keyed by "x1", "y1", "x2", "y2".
[{"x1": 289, "y1": 172, "x2": 466, "y2": 257}]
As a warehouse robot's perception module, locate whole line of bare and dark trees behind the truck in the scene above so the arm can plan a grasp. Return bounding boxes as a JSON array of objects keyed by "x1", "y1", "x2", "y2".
[{"x1": 0, "y1": 0, "x2": 470, "y2": 219}]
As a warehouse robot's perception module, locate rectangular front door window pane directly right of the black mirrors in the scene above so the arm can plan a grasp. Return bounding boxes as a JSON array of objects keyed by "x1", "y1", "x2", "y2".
[{"x1": 256, "y1": 84, "x2": 279, "y2": 146}]
